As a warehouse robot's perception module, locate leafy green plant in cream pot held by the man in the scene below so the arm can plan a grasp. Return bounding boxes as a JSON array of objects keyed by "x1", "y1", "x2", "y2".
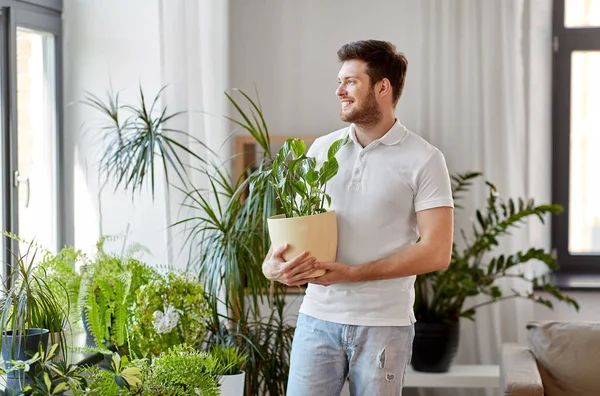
[{"x1": 252, "y1": 138, "x2": 349, "y2": 277}]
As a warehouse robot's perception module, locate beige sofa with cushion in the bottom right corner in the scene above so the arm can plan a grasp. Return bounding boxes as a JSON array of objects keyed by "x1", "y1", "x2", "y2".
[{"x1": 500, "y1": 321, "x2": 600, "y2": 396}]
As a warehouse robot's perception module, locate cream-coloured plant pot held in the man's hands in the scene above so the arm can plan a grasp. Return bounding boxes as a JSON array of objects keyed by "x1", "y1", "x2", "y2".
[{"x1": 267, "y1": 211, "x2": 337, "y2": 278}]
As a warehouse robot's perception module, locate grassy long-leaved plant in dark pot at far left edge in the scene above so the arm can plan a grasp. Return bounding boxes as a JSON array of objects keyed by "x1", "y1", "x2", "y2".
[{"x1": 0, "y1": 243, "x2": 68, "y2": 394}]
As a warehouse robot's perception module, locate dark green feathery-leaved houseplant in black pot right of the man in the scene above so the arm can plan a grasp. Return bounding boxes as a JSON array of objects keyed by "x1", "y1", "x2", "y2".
[{"x1": 412, "y1": 172, "x2": 579, "y2": 372}]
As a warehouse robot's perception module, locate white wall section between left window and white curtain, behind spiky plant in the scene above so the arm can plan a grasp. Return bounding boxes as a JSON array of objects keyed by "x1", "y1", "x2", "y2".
[{"x1": 63, "y1": 0, "x2": 166, "y2": 262}]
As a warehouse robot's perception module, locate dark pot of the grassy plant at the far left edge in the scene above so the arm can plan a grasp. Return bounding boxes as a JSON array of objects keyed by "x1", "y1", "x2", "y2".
[{"x1": 2, "y1": 329, "x2": 50, "y2": 396}]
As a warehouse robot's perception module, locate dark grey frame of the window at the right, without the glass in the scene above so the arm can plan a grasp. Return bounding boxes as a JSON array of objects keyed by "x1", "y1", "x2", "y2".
[{"x1": 552, "y1": 0, "x2": 600, "y2": 289}]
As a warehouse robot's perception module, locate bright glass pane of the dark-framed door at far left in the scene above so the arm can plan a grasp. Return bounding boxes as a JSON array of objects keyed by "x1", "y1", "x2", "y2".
[{"x1": 12, "y1": 26, "x2": 58, "y2": 251}]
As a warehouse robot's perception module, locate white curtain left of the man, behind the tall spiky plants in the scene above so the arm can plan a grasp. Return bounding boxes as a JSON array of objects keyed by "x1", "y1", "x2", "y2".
[{"x1": 159, "y1": 0, "x2": 231, "y2": 268}]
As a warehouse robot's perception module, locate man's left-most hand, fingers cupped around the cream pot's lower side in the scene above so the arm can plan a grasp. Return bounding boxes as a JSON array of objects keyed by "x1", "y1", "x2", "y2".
[{"x1": 263, "y1": 243, "x2": 316, "y2": 286}]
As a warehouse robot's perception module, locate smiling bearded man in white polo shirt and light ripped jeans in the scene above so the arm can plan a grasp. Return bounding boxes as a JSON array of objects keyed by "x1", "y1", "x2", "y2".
[{"x1": 263, "y1": 40, "x2": 453, "y2": 396}]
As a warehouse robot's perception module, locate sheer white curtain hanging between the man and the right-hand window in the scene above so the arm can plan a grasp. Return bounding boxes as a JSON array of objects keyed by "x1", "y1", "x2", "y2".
[{"x1": 405, "y1": 0, "x2": 552, "y2": 395}]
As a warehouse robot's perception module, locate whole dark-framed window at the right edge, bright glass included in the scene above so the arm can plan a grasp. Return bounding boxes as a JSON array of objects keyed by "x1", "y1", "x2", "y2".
[{"x1": 552, "y1": 0, "x2": 600, "y2": 286}]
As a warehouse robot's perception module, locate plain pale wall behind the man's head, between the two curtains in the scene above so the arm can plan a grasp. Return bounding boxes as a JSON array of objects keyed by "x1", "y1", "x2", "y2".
[{"x1": 230, "y1": 0, "x2": 420, "y2": 136}]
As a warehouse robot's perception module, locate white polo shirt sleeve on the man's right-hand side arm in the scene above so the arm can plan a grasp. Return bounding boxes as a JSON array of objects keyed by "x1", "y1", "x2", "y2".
[{"x1": 414, "y1": 150, "x2": 454, "y2": 212}]
